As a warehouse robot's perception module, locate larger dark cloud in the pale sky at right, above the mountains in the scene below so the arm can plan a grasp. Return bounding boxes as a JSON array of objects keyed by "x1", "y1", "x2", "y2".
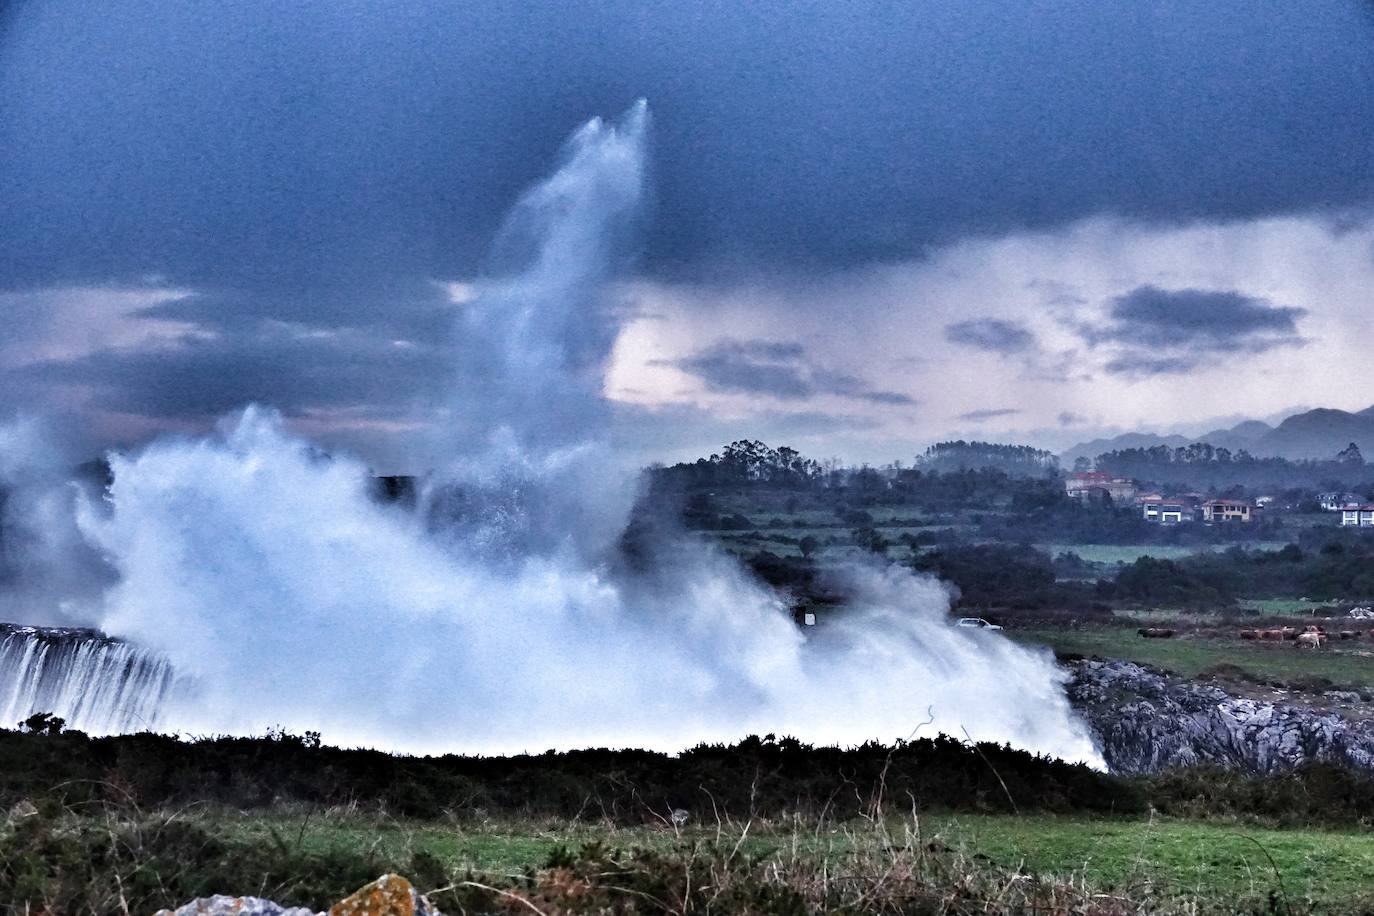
[{"x1": 1081, "y1": 286, "x2": 1307, "y2": 375}]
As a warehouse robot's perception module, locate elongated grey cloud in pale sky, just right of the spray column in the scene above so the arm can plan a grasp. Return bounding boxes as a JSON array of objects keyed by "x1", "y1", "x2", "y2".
[{"x1": 671, "y1": 341, "x2": 915, "y2": 407}]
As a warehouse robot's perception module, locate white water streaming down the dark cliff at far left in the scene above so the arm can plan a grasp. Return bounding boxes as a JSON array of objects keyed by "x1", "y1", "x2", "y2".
[{"x1": 0, "y1": 623, "x2": 176, "y2": 735}]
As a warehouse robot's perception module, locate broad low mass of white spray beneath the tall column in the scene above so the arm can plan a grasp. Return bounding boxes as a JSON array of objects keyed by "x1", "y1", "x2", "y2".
[{"x1": 84, "y1": 411, "x2": 1096, "y2": 761}]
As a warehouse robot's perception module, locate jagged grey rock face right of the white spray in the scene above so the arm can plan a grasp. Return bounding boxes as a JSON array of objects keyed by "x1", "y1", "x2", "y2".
[{"x1": 1068, "y1": 661, "x2": 1374, "y2": 773}]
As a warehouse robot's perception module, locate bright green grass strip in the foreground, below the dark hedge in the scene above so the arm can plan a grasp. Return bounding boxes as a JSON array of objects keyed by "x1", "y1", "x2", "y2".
[{"x1": 203, "y1": 813, "x2": 1374, "y2": 912}]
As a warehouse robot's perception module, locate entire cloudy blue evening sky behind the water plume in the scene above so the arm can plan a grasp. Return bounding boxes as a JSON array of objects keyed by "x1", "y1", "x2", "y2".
[{"x1": 0, "y1": 0, "x2": 1374, "y2": 472}]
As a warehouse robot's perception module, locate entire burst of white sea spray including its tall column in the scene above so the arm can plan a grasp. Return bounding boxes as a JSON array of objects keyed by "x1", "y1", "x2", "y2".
[{"x1": 2, "y1": 104, "x2": 1099, "y2": 764}]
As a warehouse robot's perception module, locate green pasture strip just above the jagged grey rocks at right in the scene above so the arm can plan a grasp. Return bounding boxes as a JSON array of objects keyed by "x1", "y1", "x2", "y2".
[{"x1": 1007, "y1": 626, "x2": 1374, "y2": 687}]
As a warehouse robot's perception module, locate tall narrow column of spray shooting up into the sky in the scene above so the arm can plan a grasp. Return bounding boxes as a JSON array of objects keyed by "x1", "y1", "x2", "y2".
[{"x1": 425, "y1": 100, "x2": 649, "y2": 560}]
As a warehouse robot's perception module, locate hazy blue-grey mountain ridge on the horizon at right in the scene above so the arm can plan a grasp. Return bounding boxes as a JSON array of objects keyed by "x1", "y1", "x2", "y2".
[{"x1": 1059, "y1": 407, "x2": 1374, "y2": 467}]
